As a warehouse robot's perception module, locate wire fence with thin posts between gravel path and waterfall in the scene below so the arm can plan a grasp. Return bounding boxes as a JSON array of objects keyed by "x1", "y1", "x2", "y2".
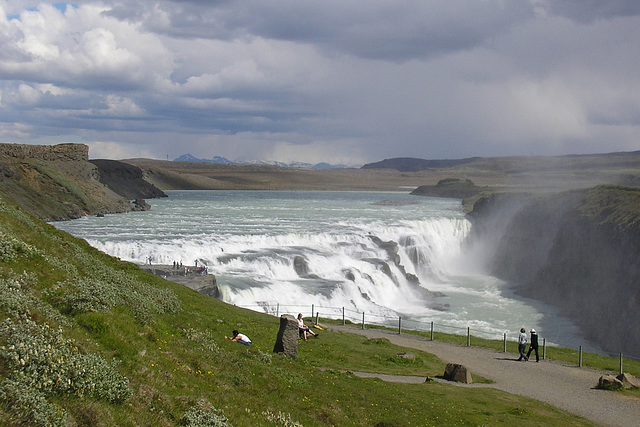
[{"x1": 241, "y1": 302, "x2": 640, "y2": 374}]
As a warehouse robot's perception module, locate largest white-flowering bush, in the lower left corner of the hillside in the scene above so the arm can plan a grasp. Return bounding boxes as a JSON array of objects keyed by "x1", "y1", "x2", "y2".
[{"x1": 0, "y1": 318, "x2": 131, "y2": 424}]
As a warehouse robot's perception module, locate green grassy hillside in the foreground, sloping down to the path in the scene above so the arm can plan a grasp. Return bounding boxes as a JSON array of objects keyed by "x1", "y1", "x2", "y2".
[{"x1": 0, "y1": 199, "x2": 589, "y2": 426}]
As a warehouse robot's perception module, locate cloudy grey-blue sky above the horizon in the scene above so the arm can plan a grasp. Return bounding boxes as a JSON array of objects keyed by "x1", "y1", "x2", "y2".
[{"x1": 0, "y1": 0, "x2": 640, "y2": 165}]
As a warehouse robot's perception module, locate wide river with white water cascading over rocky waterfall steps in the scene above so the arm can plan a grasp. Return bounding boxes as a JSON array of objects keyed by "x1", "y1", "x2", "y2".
[{"x1": 55, "y1": 191, "x2": 596, "y2": 352}]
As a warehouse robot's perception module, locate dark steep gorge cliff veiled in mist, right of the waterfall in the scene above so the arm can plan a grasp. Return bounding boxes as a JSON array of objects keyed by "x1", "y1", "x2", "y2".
[{"x1": 469, "y1": 186, "x2": 640, "y2": 356}]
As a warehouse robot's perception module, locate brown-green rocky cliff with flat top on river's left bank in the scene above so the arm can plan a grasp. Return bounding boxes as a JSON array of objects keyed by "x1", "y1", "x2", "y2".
[{"x1": 0, "y1": 144, "x2": 164, "y2": 221}]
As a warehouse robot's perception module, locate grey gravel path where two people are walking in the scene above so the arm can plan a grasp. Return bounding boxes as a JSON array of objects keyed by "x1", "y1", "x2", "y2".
[{"x1": 330, "y1": 326, "x2": 640, "y2": 427}]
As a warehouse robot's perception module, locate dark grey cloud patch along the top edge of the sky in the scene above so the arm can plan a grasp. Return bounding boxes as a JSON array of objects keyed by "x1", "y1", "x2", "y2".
[{"x1": 109, "y1": 0, "x2": 534, "y2": 60}]
